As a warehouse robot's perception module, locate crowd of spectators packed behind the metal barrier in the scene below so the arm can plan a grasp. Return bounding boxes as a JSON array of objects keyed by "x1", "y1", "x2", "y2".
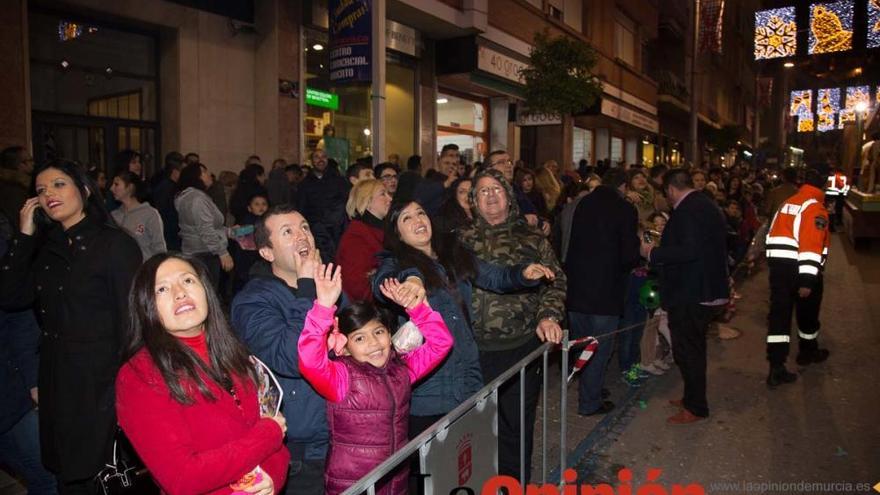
[{"x1": 0, "y1": 145, "x2": 827, "y2": 495}]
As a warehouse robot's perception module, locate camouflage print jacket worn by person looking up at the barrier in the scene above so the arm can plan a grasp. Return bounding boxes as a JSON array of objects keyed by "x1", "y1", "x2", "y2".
[{"x1": 459, "y1": 170, "x2": 566, "y2": 351}]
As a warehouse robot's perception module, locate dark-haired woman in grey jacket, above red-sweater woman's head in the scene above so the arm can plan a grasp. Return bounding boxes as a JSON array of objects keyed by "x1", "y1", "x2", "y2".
[{"x1": 174, "y1": 163, "x2": 234, "y2": 289}]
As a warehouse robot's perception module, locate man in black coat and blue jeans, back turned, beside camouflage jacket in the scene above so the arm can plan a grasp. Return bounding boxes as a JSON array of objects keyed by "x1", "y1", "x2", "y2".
[{"x1": 565, "y1": 168, "x2": 639, "y2": 416}]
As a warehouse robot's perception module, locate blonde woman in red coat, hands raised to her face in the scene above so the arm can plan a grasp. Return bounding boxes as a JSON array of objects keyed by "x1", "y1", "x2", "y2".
[{"x1": 336, "y1": 179, "x2": 391, "y2": 301}]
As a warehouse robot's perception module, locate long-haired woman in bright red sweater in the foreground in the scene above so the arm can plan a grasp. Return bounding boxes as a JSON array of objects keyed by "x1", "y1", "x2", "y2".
[{"x1": 116, "y1": 254, "x2": 290, "y2": 495}]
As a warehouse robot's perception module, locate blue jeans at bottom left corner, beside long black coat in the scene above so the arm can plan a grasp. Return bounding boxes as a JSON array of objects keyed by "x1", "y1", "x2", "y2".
[{"x1": 0, "y1": 410, "x2": 58, "y2": 495}]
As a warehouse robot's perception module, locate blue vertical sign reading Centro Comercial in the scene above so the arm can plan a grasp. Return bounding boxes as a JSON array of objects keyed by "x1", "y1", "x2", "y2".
[{"x1": 328, "y1": 0, "x2": 372, "y2": 83}]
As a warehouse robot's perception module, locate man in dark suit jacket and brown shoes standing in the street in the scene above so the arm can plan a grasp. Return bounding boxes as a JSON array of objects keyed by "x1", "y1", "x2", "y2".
[{"x1": 641, "y1": 169, "x2": 729, "y2": 424}]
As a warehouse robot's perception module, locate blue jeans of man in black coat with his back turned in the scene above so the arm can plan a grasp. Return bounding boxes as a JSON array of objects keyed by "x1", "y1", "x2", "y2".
[{"x1": 568, "y1": 312, "x2": 620, "y2": 414}]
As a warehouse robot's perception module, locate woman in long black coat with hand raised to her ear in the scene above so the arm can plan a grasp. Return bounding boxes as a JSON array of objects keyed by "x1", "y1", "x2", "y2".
[{"x1": 0, "y1": 162, "x2": 141, "y2": 495}]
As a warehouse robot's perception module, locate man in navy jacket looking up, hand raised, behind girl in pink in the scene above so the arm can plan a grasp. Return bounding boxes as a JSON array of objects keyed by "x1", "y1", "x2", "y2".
[{"x1": 230, "y1": 205, "x2": 329, "y2": 495}]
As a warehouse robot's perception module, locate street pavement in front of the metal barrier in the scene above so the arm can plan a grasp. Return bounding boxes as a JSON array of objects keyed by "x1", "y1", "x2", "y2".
[{"x1": 533, "y1": 235, "x2": 880, "y2": 494}]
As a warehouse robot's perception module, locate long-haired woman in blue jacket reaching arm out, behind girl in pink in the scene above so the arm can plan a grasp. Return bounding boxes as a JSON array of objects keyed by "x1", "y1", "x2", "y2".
[{"x1": 373, "y1": 201, "x2": 553, "y2": 437}]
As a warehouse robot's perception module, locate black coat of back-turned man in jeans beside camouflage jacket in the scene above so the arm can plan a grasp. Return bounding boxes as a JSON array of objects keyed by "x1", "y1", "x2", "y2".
[{"x1": 565, "y1": 186, "x2": 640, "y2": 316}]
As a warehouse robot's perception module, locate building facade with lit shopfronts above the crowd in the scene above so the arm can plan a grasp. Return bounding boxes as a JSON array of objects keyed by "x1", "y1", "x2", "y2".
[{"x1": 0, "y1": 0, "x2": 660, "y2": 175}]
